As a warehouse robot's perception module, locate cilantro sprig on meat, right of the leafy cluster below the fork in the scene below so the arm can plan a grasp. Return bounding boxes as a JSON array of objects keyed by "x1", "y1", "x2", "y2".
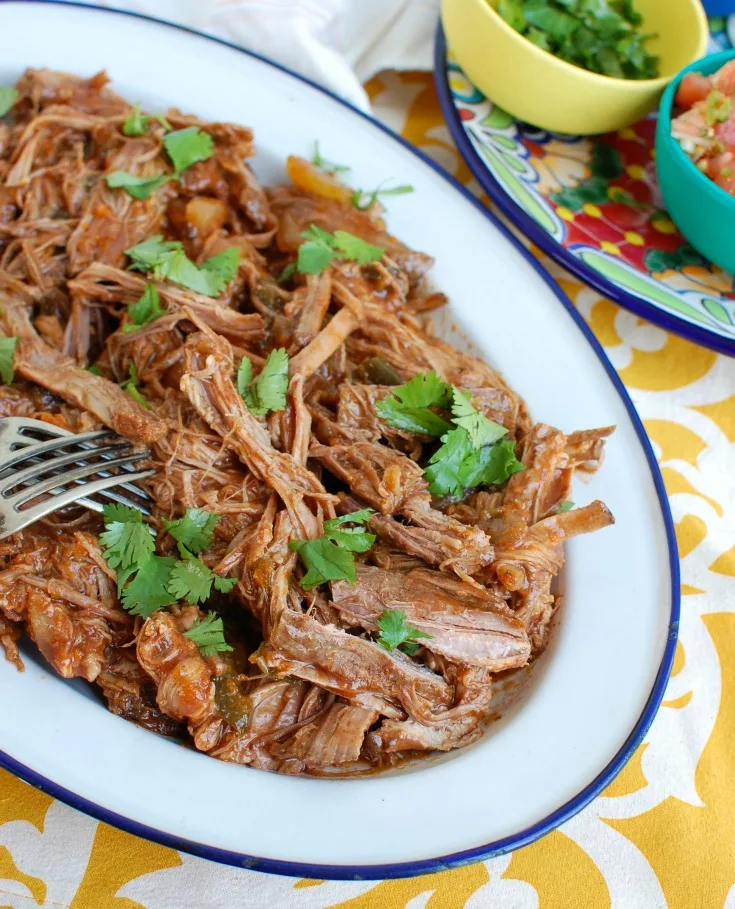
[{"x1": 288, "y1": 508, "x2": 375, "y2": 590}]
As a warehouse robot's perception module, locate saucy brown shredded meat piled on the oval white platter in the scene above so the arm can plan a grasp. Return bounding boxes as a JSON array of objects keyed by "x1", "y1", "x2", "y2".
[{"x1": 0, "y1": 70, "x2": 612, "y2": 773}]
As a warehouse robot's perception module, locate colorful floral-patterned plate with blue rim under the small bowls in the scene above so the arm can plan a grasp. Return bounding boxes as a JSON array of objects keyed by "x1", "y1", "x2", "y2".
[{"x1": 434, "y1": 16, "x2": 735, "y2": 355}]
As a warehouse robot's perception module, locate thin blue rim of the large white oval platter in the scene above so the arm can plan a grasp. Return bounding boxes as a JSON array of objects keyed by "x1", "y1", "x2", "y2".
[{"x1": 0, "y1": 0, "x2": 681, "y2": 880}]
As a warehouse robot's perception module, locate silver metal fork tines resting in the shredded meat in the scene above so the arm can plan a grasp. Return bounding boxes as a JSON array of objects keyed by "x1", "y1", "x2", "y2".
[{"x1": 0, "y1": 417, "x2": 155, "y2": 540}]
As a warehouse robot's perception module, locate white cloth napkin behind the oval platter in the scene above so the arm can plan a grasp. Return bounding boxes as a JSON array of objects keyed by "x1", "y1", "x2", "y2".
[{"x1": 81, "y1": 0, "x2": 439, "y2": 110}]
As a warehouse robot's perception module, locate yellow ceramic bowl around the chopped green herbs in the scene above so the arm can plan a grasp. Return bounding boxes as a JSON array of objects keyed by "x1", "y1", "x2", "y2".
[{"x1": 442, "y1": 0, "x2": 708, "y2": 135}]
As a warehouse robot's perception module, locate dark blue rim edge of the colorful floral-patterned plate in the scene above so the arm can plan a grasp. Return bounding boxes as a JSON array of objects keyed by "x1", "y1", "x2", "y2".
[{"x1": 434, "y1": 22, "x2": 735, "y2": 357}]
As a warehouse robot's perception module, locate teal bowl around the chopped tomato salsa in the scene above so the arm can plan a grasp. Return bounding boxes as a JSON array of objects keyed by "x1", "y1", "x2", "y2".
[{"x1": 656, "y1": 50, "x2": 735, "y2": 272}]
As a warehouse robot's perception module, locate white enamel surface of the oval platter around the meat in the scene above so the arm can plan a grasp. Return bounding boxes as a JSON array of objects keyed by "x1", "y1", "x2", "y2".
[{"x1": 0, "y1": 2, "x2": 672, "y2": 873}]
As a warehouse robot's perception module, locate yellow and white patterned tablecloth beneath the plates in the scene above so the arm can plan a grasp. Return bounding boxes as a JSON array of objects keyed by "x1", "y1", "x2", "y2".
[{"x1": 0, "y1": 73, "x2": 735, "y2": 909}]
